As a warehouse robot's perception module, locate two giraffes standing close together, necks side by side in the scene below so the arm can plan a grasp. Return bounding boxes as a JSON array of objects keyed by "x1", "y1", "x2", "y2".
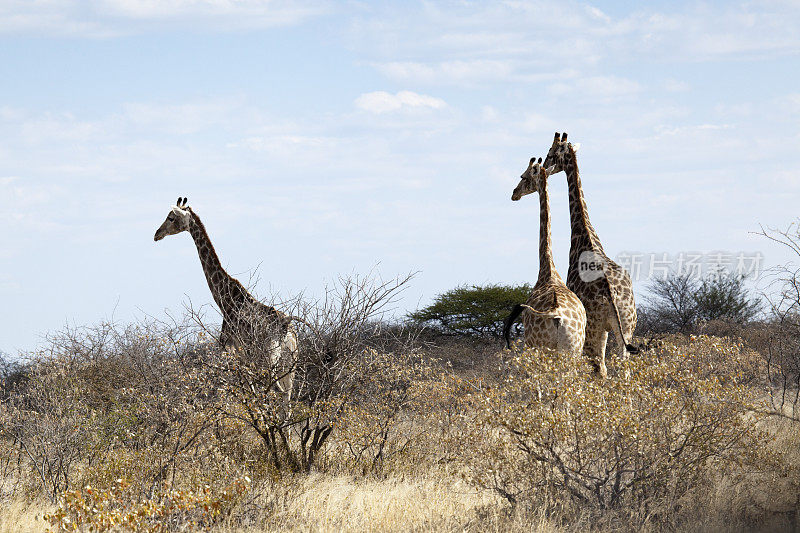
[{"x1": 503, "y1": 132, "x2": 638, "y2": 378}]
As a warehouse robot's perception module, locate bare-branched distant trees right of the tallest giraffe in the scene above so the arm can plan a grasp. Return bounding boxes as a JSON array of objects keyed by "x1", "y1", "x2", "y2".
[{"x1": 639, "y1": 272, "x2": 761, "y2": 333}]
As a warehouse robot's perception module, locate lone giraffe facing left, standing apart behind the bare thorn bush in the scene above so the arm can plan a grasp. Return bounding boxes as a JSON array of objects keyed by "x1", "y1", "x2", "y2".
[{"x1": 153, "y1": 198, "x2": 297, "y2": 401}]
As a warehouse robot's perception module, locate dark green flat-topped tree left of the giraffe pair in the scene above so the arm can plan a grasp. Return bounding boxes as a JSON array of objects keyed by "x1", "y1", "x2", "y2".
[{"x1": 408, "y1": 284, "x2": 533, "y2": 337}]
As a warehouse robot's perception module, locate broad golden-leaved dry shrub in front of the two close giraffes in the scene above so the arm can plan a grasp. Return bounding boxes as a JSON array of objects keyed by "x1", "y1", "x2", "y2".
[{"x1": 465, "y1": 339, "x2": 765, "y2": 524}]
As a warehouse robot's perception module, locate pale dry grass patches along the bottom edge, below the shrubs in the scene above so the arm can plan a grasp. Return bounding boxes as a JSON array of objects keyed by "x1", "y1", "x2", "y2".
[{"x1": 0, "y1": 462, "x2": 800, "y2": 533}]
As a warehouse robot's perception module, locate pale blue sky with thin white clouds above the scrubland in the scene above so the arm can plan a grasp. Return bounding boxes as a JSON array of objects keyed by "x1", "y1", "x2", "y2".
[{"x1": 0, "y1": 0, "x2": 800, "y2": 353}]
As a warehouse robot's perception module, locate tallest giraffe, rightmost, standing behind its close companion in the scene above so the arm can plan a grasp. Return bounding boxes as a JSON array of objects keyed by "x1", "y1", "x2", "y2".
[{"x1": 544, "y1": 132, "x2": 639, "y2": 378}]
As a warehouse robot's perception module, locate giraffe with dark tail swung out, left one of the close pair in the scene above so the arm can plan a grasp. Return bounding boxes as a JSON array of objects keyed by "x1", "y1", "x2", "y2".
[{"x1": 503, "y1": 157, "x2": 586, "y2": 355}]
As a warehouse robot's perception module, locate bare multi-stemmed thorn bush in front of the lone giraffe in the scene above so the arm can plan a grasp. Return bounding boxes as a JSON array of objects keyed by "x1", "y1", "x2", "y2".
[{"x1": 178, "y1": 276, "x2": 411, "y2": 472}]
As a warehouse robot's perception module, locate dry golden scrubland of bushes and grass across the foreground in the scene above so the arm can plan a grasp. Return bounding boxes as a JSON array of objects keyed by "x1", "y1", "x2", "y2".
[{"x1": 0, "y1": 328, "x2": 800, "y2": 533}]
